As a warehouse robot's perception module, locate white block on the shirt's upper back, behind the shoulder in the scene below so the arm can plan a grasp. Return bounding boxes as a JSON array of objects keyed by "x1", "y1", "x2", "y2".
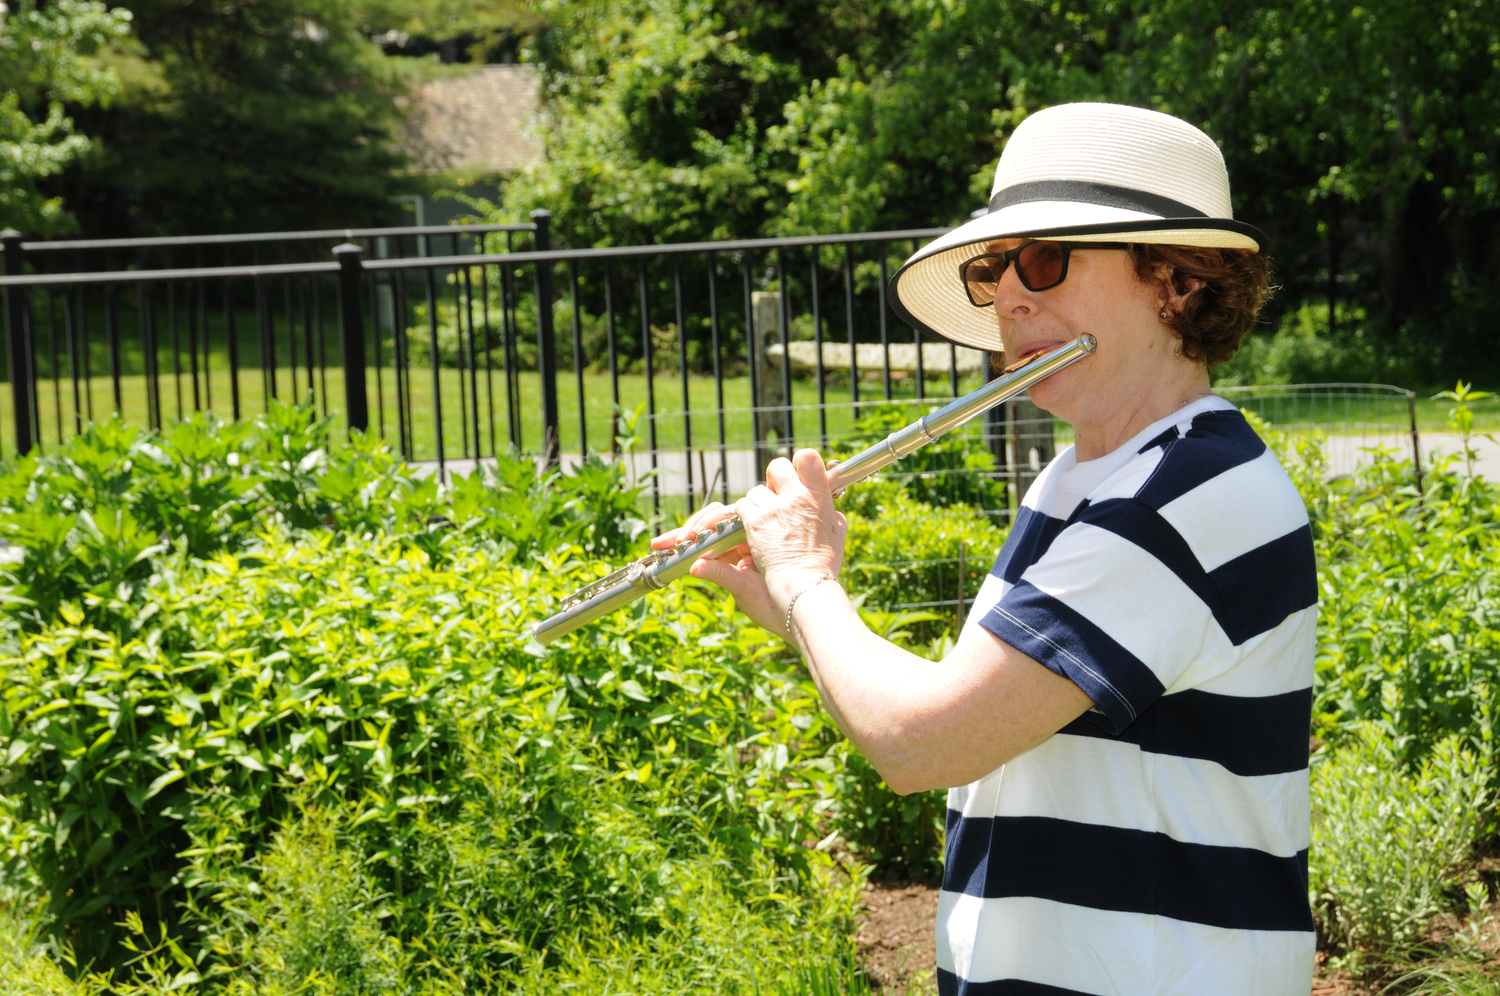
[{"x1": 1158, "y1": 450, "x2": 1308, "y2": 570}]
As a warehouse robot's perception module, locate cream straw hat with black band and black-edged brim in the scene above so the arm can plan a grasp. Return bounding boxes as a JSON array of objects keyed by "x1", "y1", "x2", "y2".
[{"x1": 890, "y1": 104, "x2": 1266, "y2": 351}]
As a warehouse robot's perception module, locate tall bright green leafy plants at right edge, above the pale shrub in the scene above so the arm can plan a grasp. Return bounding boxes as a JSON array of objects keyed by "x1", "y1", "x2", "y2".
[{"x1": 1314, "y1": 447, "x2": 1500, "y2": 761}]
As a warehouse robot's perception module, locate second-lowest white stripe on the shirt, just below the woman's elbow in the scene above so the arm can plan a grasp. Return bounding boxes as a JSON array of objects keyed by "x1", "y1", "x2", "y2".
[{"x1": 950, "y1": 734, "x2": 1311, "y2": 860}]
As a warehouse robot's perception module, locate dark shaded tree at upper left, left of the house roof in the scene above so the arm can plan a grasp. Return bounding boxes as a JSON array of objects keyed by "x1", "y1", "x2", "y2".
[{"x1": 56, "y1": 0, "x2": 417, "y2": 234}]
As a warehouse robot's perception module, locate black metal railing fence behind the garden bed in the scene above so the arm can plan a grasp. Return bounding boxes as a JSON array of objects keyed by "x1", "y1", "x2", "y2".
[{"x1": 0, "y1": 212, "x2": 1080, "y2": 510}]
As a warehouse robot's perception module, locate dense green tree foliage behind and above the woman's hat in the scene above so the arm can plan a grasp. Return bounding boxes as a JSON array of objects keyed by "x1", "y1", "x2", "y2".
[{"x1": 507, "y1": 0, "x2": 1500, "y2": 378}]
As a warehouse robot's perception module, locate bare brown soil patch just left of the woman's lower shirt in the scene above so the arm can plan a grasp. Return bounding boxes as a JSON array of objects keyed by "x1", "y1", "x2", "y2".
[{"x1": 855, "y1": 882, "x2": 938, "y2": 996}]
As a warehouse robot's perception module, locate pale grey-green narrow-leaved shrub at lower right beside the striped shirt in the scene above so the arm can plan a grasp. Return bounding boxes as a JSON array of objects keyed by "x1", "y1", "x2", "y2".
[{"x1": 1308, "y1": 723, "x2": 1490, "y2": 956}]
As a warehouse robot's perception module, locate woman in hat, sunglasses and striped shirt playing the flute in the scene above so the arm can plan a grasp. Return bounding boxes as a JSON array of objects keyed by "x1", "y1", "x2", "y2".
[{"x1": 659, "y1": 104, "x2": 1317, "y2": 996}]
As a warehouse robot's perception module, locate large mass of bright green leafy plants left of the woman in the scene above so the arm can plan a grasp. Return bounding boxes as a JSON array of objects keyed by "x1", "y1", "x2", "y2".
[{"x1": 0, "y1": 408, "x2": 902, "y2": 993}]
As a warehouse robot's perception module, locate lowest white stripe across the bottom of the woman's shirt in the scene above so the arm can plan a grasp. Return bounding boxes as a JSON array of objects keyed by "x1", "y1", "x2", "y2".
[{"x1": 938, "y1": 893, "x2": 1316, "y2": 996}]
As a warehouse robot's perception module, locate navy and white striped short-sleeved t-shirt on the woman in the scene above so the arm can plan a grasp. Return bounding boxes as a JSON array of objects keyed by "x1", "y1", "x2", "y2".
[{"x1": 938, "y1": 398, "x2": 1317, "y2": 996}]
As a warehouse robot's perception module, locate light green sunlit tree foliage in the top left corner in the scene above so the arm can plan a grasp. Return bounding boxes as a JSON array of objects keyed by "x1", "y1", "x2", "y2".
[{"x1": 0, "y1": 0, "x2": 131, "y2": 234}]
